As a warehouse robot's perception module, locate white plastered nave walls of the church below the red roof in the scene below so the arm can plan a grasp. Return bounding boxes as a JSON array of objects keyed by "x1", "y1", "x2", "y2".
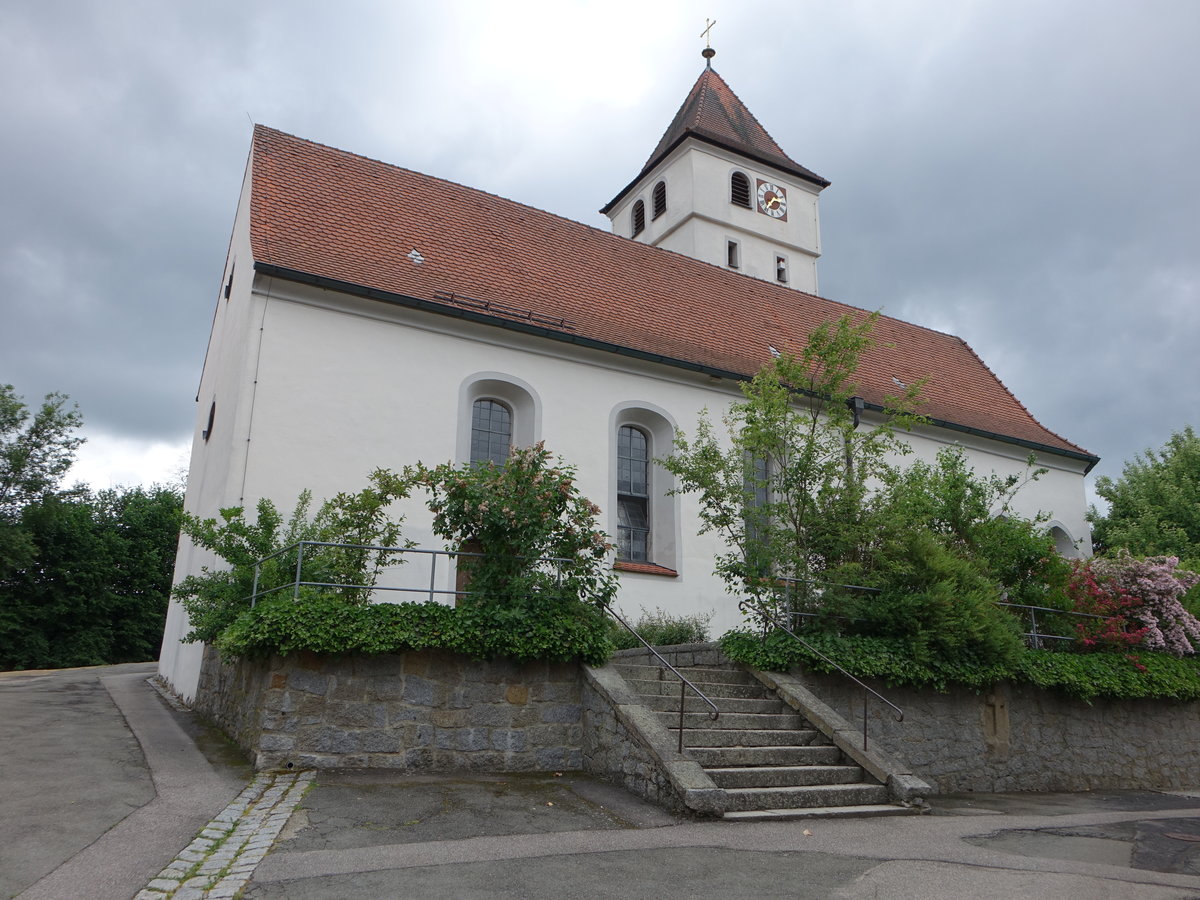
[{"x1": 161, "y1": 271, "x2": 1087, "y2": 696}]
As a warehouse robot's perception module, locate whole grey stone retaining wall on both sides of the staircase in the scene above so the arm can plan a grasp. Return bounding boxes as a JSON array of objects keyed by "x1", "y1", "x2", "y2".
[{"x1": 196, "y1": 644, "x2": 1200, "y2": 796}]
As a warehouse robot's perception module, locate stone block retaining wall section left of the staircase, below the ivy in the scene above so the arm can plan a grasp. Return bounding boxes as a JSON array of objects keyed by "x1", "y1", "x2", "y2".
[{"x1": 194, "y1": 648, "x2": 582, "y2": 772}]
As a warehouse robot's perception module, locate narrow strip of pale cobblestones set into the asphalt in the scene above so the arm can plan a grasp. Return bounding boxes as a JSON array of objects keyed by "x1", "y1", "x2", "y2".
[{"x1": 134, "y1": 772, "x2": 313, "y2": 900}]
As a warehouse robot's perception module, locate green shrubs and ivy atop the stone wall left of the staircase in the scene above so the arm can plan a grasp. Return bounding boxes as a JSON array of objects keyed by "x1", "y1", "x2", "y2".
[{"x1": 176, "y1": 444, "x2": 616, "y2": 664}]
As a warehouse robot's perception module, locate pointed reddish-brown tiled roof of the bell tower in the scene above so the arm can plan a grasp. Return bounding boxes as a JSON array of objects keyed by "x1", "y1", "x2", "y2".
[{"x1": 600, "y1": 65, "x2": 829, "y2": 212}]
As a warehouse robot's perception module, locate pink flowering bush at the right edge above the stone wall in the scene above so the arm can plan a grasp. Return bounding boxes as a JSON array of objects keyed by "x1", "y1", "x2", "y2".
[{"x1": 1091, "y1": 551, "x2": 1200, "y2": 656}]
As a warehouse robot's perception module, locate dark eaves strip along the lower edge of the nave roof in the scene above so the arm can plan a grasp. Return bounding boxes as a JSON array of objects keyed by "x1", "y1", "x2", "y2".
[{"x1": 254, "y1": 260, "x2": 1100, "y2": 474}]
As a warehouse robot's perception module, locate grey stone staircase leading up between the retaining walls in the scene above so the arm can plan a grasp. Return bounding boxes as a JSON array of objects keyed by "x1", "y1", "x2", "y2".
[{"x1": 617, "y1": 664, "x2": 916, "y2": 820}]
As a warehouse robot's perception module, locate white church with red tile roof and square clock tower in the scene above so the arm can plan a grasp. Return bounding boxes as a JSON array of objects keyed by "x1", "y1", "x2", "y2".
[{"x1": 160, "y1": 54, "x2": 1098, "y2": 698}]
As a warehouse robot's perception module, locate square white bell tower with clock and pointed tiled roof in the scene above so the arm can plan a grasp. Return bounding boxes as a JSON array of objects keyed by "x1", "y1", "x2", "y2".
[{"x1": 600, "y1": 47, "x2": 829, "y2": 293}]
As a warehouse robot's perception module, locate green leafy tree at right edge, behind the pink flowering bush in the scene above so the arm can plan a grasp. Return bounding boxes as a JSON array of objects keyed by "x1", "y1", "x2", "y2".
[{"x1": 1090, "y1": 425, "x2": 1200, "y2": 568}]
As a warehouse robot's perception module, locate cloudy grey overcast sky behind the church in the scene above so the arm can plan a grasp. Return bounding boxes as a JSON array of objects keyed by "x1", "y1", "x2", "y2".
[{"x1": 0, "y1": 0, "x2": 1200, "y2": 508}]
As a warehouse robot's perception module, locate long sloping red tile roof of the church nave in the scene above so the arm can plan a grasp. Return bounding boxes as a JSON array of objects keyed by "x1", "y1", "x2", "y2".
[{"x1": 251, "y1": 126, "x2": 1094, "y2": 458}]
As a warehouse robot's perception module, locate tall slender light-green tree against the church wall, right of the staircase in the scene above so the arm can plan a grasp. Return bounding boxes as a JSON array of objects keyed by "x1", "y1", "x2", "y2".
[{"x1": 661, "y1": 313, "x2": 920, "y2": 628}]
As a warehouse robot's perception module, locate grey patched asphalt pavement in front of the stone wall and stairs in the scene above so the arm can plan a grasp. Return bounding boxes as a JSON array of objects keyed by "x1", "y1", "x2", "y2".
[{"x1": 7, "y1": 664, "x2": 1200, "y2": 900}]
